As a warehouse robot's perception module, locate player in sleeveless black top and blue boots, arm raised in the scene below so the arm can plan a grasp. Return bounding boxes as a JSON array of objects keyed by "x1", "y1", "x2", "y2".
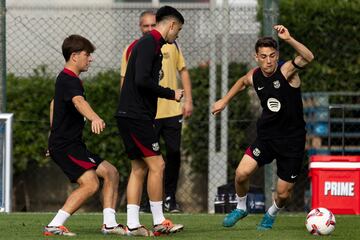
[{"x1": 212, "y1": 25, "x2": 314, "y2": 230}]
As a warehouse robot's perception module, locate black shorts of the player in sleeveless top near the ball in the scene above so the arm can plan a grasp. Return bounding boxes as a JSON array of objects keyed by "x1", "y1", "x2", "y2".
[{"x1": 245, "y1": 136, "x2": 305, "y2": 183}]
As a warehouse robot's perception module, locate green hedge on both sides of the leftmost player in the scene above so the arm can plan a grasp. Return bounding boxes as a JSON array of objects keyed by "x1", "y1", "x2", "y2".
[{"x1": 7, "y1": 66, "x2": 129, "y2": 179}]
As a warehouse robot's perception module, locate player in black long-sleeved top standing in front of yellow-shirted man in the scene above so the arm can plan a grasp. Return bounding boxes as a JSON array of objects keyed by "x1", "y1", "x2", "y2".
[{"x1": 116, "y1": 6, "x2": 184, "y2": 236}]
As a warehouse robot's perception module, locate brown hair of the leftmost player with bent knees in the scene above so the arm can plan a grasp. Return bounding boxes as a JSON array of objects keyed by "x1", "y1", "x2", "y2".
[{"x1": 61, "y1": 34, "x2": 95, "y2": 62}]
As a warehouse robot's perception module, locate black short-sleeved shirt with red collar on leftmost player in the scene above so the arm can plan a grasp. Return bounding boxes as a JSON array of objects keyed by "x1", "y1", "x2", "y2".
[{"x1": 49, "y1": 68, "x2": 85, "y2": 149}]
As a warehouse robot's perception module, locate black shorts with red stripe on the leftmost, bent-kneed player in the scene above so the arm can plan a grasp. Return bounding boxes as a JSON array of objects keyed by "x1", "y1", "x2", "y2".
[{"x1": 49, "y1": 143, "x2": 103, "y2": 182}]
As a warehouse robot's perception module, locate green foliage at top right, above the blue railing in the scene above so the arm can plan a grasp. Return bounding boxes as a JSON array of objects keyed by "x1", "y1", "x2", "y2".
[{"x1": 279, "y1": 0, "x2": 360, "y2": 91}]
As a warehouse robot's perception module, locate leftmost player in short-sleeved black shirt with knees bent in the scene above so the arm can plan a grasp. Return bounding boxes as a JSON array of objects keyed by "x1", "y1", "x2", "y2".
[{"x1": 43, "y1": 35, "x2": 125, "y2": 236}]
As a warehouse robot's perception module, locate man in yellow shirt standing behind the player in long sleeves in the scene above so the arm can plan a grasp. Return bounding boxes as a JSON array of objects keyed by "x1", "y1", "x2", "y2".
[{"x1": 121, "y1": 11, "x2": 193, "y2": 213}]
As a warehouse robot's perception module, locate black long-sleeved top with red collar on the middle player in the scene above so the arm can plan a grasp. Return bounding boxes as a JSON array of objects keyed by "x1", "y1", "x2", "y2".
[{"x1": 116, "y1": 30, "x2": 175, "y2": 120}]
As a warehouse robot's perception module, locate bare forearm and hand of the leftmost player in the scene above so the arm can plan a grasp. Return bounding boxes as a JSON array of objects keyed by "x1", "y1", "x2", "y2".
[{"x1": 72, "y1": 96, "x2": 105, "y2": 134}]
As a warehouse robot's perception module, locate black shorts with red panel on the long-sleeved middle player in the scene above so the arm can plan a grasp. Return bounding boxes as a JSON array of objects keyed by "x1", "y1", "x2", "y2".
[{"x1": 117, "y1": 117, "x2": 160, "y2": 160}]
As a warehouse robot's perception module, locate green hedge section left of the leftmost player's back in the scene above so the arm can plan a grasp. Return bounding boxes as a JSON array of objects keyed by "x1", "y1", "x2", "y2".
[{"x1": 7, "y1": 66, "x2": 54, "y2": 172}]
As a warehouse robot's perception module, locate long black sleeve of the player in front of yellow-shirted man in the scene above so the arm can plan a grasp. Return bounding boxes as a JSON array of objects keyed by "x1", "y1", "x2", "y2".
[{"x1": 135, "y1": 40, "x2": 175, "y2": 99}]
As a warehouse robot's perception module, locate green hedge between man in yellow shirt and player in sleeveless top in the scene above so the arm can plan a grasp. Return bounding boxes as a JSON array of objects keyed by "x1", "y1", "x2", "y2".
[{"x1": 183, "y1": 63, "x2": 249, "y2": 176}]
